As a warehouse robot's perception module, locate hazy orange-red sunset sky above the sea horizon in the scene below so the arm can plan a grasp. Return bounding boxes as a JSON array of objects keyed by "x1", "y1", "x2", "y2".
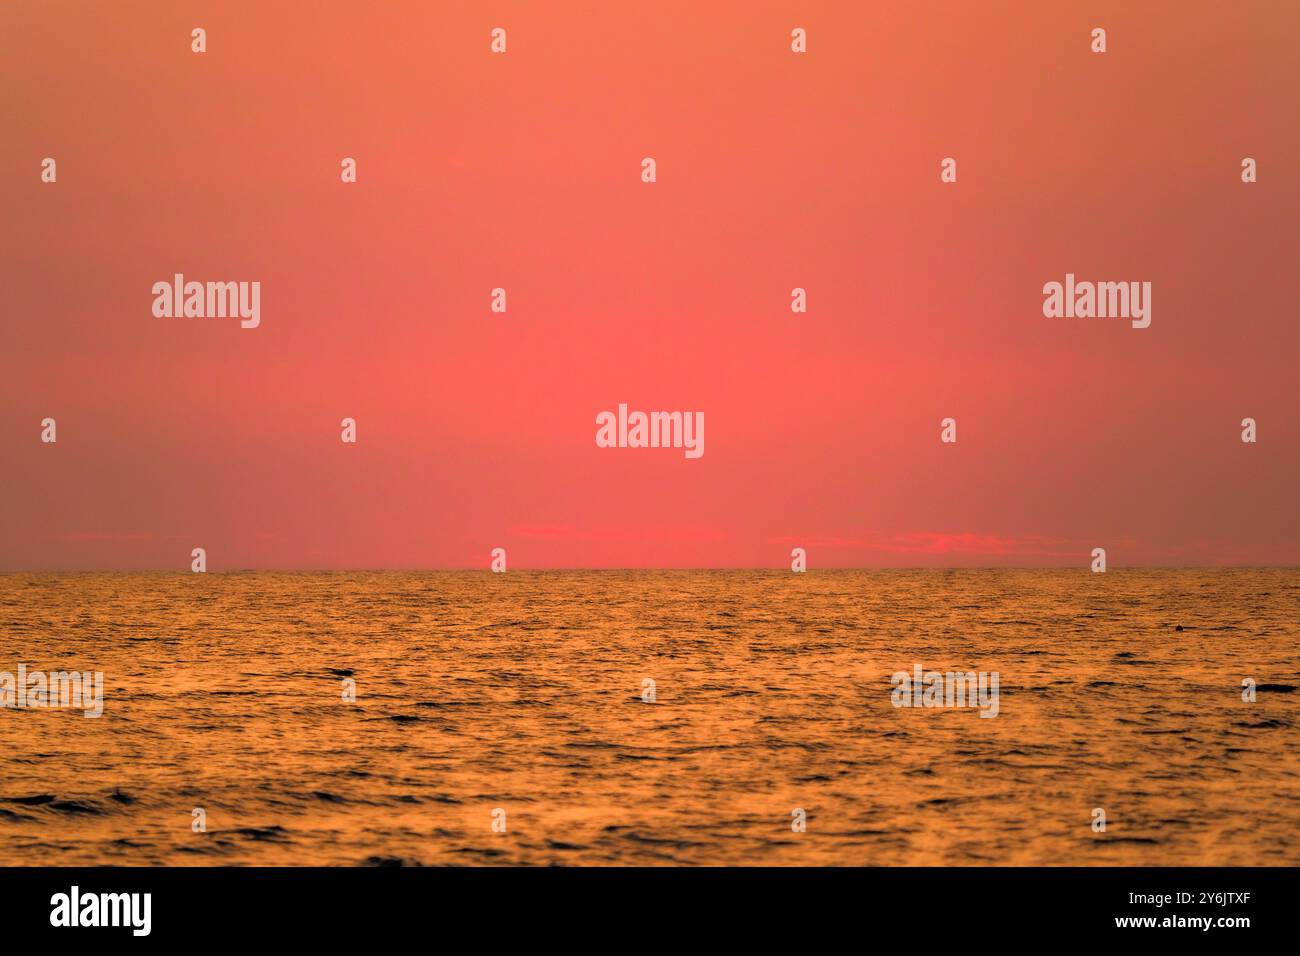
[{"x1": 0, "y1": 0, "x2": 1300, "y2": 571}]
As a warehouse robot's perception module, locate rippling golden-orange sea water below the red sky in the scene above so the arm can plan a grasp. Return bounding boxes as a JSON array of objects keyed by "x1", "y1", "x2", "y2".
[{"x1": 0, "y1": 568, "x2": 1300, "y2": 866}]
